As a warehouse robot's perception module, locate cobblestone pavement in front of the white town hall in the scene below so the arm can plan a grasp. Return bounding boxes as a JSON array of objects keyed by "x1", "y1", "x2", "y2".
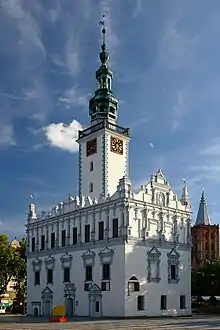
[{"x1": 0, "y1": 315, "x2": 220, "y2": 330}]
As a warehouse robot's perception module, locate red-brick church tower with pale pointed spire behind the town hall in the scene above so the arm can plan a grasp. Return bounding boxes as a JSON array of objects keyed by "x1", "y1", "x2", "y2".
[{"x1": 192, "y1": 190, "x2": 219, "y2": 270}]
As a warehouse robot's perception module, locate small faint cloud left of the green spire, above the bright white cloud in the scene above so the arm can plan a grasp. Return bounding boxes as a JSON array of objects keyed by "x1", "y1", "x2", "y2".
[{"x1": 59, "y1": 85, "x2": 88, "y2": 108}]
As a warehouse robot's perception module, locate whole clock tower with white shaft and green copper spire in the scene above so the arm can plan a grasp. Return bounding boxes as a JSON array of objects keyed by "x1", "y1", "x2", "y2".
[{"x1": 77, "y1": 21, "x2": 130, "y2": 199}]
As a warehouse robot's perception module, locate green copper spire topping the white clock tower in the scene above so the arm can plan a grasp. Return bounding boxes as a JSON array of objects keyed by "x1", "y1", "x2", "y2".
[{"x1": 89, "y1": 15, "x2": 118, "y2": 125}]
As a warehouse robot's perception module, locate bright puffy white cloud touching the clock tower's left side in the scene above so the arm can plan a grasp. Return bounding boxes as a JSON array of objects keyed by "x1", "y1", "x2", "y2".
[{"x1": 43, "y1": 120, "x2": 83, "y2": 152}]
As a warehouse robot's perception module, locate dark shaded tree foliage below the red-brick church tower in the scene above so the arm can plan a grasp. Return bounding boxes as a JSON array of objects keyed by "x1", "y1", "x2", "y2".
[{"x1": 192, "y1": 259, "x2": 220, "y2": 296}]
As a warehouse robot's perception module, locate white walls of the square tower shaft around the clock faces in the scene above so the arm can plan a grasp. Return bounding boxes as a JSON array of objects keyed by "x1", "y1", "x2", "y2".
[{"x1": 78, "y1": 124, "x2": 130, "y2": 198}]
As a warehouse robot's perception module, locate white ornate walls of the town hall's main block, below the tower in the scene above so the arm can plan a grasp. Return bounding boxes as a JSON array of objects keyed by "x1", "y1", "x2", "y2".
[{"x1": 27, "y1": 170, "x2": 191, "y2": 317}]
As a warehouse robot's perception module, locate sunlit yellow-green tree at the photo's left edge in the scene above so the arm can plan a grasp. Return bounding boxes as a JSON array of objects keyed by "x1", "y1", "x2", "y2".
[{"x1": 0, "y1": 234, "x2": 15, "y2": 294}]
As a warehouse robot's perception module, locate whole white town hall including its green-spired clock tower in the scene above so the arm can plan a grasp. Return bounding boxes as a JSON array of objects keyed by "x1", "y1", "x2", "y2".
[{"x1": 27, "y1": 22, "x2": 191, "y2": 317}]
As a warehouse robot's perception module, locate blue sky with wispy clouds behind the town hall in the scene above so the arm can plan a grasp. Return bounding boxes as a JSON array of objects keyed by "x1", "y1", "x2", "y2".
[{"x1": 0, "y1": 0, "x2": 220, "y2": 237}]
